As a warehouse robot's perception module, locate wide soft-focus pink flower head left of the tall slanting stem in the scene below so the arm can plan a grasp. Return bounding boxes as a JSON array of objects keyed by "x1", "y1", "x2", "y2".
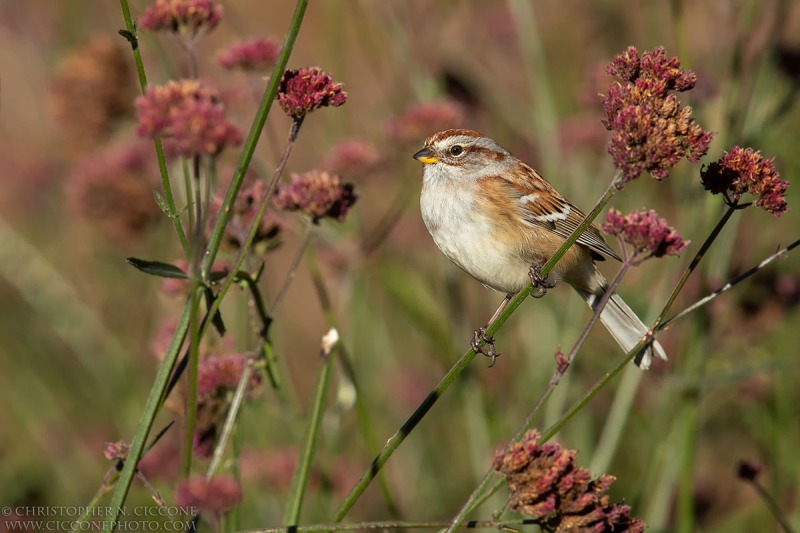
[{"x1": 136, "y1": 80, "x2": 242, "y2": 157}]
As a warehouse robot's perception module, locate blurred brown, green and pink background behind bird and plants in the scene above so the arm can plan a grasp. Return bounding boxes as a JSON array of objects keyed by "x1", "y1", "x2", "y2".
[{"x1": 0, "y1": 0, "x2": 800, "y2": 531}]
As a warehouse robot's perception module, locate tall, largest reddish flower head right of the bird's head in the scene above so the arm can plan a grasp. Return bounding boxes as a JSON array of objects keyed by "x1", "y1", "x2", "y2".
[{"x1": 603, "y1": 46, "x2": 712, "y2": 184}]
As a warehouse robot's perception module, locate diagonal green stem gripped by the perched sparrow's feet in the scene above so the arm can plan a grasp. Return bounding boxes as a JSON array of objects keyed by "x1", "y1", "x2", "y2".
[{"x1": 333, "y1": 175, "x2": 620, "y2": 522}]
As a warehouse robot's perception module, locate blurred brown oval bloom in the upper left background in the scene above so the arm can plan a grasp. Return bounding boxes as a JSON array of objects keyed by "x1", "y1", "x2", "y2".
[{"x1": 49, "y1": 36, "x2": 135, "y2": 151}]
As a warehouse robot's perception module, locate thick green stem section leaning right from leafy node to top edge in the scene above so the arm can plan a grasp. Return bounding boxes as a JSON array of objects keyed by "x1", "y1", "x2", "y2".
[{"x1": 201, "y1": 0, "x2": 308, "y2": 279}]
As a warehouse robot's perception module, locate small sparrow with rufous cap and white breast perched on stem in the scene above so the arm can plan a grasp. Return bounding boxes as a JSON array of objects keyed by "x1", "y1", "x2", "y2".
[{"x1": 414, "y1": 129, "x2": 667, "y2": 368}]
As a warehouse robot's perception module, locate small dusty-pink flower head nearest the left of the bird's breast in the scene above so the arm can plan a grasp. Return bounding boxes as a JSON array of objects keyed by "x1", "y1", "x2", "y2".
[{"x1": 272, "y1": 170, "x2": 357, "y2": 224}]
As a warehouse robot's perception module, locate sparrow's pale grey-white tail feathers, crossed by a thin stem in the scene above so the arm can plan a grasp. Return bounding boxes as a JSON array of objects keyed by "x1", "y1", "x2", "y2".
[{"x1": 575, "y1": 289, "x2": 667, "y2": 370}]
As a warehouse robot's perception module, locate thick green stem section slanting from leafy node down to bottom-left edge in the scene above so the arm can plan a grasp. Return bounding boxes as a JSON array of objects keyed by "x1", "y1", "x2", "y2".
[{"x1": 104, "y1": 302, "x2": 191, "y2": 532}]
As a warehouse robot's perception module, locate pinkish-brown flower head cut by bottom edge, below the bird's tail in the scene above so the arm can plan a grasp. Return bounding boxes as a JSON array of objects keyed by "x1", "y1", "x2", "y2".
[{"x1": 494, "y1": 430, "x2": 644, "y2": 533}]
